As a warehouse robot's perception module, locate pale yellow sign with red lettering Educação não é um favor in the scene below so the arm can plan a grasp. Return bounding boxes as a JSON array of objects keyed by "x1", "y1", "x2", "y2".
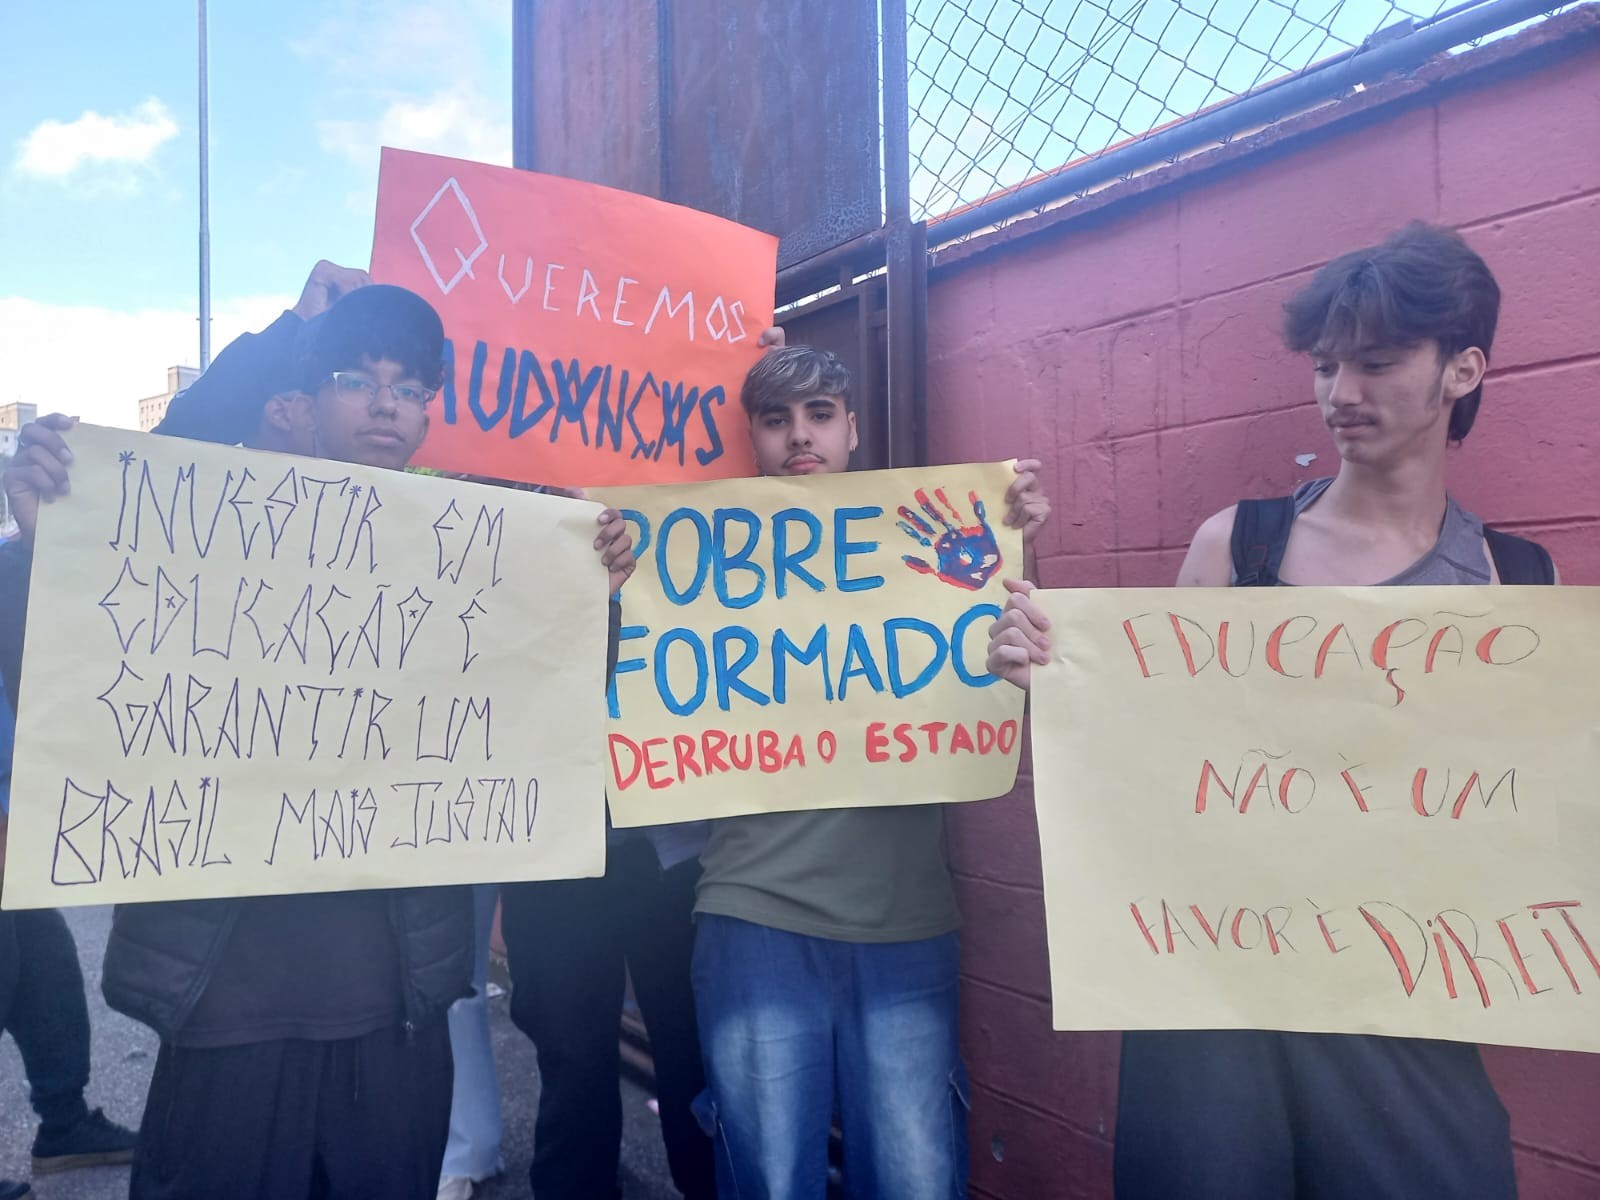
[{"x1": 1034, "y1": 587, "x2": 1600, "y2": 1051}]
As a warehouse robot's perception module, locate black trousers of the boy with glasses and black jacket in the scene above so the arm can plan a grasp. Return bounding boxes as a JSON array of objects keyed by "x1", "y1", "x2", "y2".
[{"x1": 128, "y1": 1019, "x2": 451, "y2": 1200}]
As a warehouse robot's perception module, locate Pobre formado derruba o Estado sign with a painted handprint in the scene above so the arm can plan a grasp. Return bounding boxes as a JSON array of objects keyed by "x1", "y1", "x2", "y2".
[{"x1": 592, "y1": 464, "x2": 1022, "y2": 826}]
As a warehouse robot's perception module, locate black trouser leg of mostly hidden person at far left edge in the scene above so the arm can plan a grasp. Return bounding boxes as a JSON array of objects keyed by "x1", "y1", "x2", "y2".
[{"x1": 0, "y1": 909, "x2": 90, "y2": 1130}]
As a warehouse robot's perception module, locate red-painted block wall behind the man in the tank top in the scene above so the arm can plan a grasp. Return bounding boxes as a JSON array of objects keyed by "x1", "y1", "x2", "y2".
[{"x1": 928, "y1": 25, "x2": 1600, "y2": 1200}]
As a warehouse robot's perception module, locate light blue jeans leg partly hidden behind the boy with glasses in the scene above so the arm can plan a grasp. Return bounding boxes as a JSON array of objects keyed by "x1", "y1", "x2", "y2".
[{"x1": 443, "y1": 883, "x2": 504, "y2": 1181}]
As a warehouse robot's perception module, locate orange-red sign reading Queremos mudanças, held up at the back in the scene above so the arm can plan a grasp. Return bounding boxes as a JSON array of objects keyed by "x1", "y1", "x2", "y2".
[{"x1": 373, "y1": 149, "x2": 778, "y2": 486}]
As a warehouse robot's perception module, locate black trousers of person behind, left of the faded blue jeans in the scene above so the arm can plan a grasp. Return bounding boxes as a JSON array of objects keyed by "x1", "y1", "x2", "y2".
[{"x1": 501, "y1": 838, "x2": 717, "y2": 1200}]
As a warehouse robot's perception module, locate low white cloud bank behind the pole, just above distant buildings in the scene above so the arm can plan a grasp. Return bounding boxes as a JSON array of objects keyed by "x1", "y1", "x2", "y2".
[{"x1": 0, "y1": 296, "x2": 294, "y2": 429}]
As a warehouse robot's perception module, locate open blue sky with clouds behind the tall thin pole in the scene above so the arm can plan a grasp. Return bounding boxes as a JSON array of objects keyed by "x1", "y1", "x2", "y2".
[{"x1": 0, "y1": 0, "x2": 510, "y2": 424}]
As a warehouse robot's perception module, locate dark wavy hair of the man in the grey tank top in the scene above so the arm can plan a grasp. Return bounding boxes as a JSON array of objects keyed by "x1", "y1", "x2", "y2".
[{"x1": 1283, "y1": 221, "x2": 1499, "y2": 442}]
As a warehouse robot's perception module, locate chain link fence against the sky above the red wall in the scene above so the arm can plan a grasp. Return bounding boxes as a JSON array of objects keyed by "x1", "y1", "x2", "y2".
[{"x1": 907, "y1": 0, "x2": 1558, "y2": 219}]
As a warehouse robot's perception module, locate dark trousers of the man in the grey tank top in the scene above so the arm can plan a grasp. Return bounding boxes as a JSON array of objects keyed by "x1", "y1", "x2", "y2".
[{"x1": 1115, "y1": 1030, "x2": 1517, "y2": 1200}]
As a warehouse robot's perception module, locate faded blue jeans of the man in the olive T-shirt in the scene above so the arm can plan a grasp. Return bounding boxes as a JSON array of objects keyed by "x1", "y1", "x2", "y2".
[{"x1": 694, "y1": 915, "x2": 966, "y2": 1200}]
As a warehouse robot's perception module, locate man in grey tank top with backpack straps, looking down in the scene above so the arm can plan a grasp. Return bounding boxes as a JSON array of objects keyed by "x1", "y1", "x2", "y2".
[{"x1": 989, "y1": 222, "x2": 1557, "y2": 1200}]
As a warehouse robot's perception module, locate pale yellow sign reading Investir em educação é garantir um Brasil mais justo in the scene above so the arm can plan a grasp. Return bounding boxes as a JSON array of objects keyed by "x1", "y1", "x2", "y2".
[{"x1": 3, "y1": 426, "x2": 606, "y2": 907}]
